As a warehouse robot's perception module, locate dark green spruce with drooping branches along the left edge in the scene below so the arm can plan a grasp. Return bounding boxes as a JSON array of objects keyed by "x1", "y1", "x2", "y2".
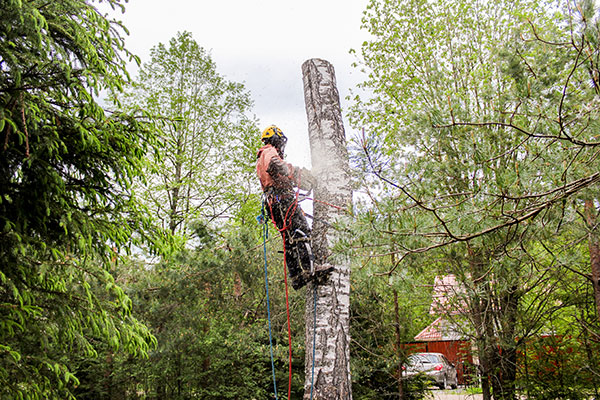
[{"x1": 0, "y1": 0, "x2": 161, "y2": 398}]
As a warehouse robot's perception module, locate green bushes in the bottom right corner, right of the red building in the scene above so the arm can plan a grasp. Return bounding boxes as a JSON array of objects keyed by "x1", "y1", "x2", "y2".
[{"x1": 510, "y1": 223, "x2": 600, "y2": 399}]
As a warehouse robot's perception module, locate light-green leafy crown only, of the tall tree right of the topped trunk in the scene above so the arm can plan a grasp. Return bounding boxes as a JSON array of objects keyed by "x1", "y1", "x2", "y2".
[{"x1": 350, "y1": 1, "x2": 596, "y2": 247}]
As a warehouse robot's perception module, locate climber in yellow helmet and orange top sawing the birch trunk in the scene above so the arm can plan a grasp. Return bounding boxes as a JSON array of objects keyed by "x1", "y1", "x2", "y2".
[{"x1": 256, "y1": 125, "x2": 333, "y2": 290}]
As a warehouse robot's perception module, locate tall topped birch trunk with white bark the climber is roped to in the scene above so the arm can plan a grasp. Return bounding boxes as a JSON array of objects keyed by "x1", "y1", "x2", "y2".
[{"x1": 302, "y1": 59, "x2": 352, "y2": 400}]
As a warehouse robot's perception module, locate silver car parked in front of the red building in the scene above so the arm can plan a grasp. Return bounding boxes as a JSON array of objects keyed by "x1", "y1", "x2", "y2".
[{"x1": 403, "y1": 353, "x2": 458, "y2": 389}]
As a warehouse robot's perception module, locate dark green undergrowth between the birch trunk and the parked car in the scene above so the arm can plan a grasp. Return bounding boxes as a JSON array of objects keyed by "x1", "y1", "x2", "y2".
[{"x1": 350, "y1": 258, "x2": 433, "y2": 399}]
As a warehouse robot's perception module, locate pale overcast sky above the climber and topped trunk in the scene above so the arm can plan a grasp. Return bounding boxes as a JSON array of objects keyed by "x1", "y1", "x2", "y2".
[{"x1": 109, "y1": 0, "x2": 368, "y2": 167}]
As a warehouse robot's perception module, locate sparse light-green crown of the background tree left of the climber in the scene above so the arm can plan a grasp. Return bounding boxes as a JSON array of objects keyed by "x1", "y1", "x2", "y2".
[{"x1": 118, "y1": 32, "x2": 258, "y2": 241}]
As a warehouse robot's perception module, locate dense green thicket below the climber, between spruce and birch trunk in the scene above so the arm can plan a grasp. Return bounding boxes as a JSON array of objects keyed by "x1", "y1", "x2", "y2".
[{"x1": 72, "y1": 222, "x2": 304, "y2": 399}]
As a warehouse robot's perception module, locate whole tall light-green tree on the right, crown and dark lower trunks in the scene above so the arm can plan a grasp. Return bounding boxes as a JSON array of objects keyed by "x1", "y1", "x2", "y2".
[{"x1": 351, "y1": 1, "x2": 599, "y2": 398}]
